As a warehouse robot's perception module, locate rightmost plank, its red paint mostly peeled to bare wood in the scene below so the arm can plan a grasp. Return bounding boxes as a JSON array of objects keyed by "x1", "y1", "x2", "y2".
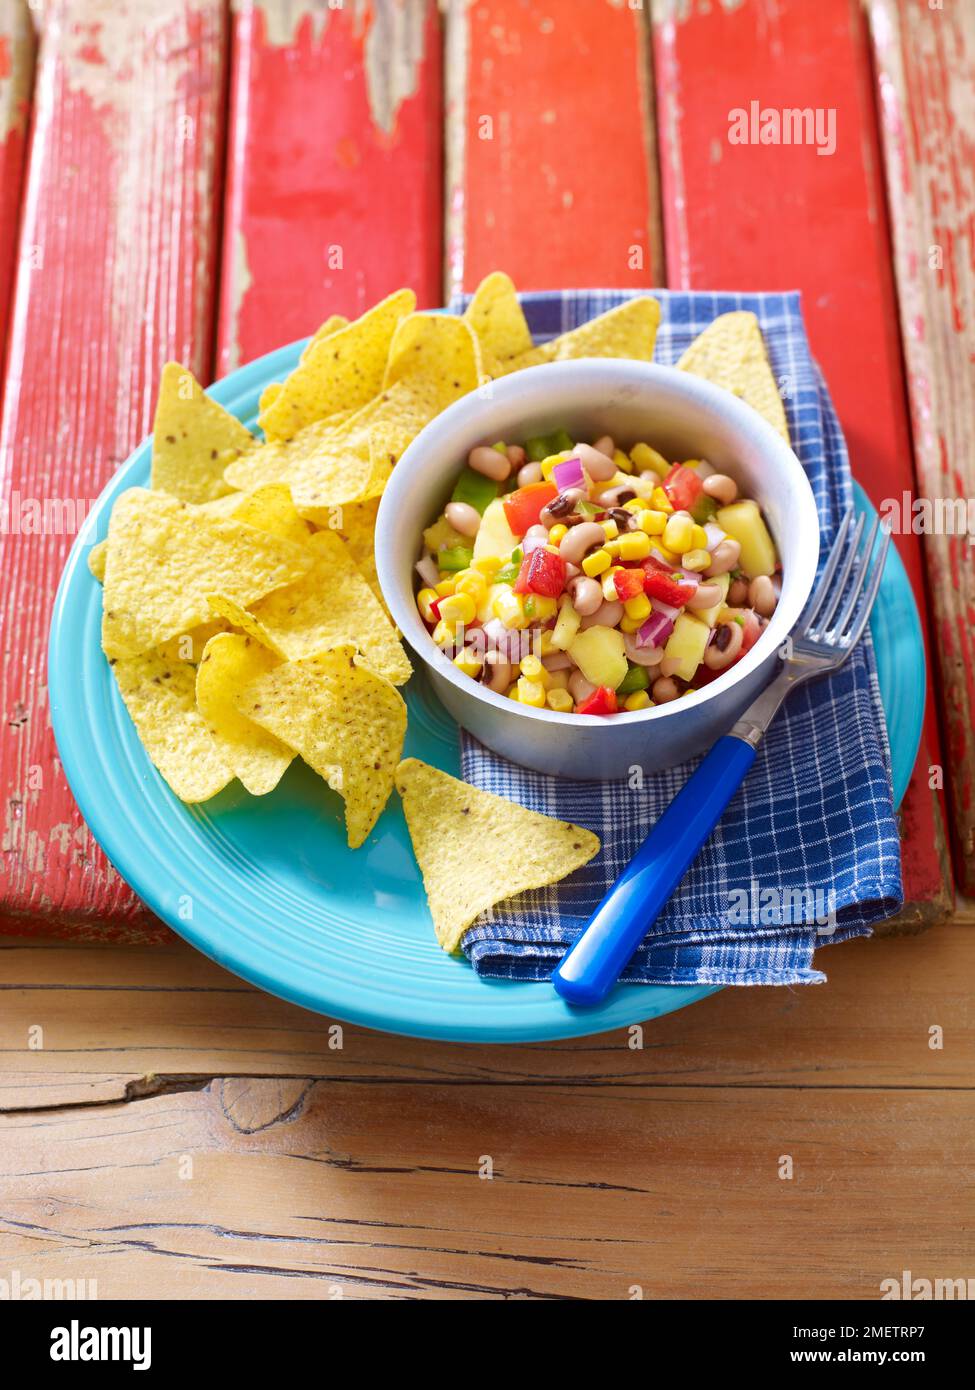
[{"x1": 869, "y1": 0, "x2": 975, "y2": 894}]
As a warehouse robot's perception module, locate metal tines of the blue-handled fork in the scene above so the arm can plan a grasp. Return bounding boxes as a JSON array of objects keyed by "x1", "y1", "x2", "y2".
[{"x1": 793, "y1": 507, "x2": 890, "y2": 664}]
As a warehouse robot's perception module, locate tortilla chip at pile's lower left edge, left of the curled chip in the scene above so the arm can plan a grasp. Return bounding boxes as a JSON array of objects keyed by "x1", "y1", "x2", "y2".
[{"x1": 111, "y1": 652, "x2": 234, "y2": 802}]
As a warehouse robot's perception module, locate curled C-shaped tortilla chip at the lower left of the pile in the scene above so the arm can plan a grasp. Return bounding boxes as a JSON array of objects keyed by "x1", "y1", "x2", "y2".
[{"x1": 196, "y1": 632, "x2": 295, "y2": 796}]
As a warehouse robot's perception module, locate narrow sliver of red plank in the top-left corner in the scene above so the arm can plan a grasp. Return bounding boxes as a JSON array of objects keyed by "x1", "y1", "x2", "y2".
[{"x1": 0, "y1": 0, "x2": 35, "y2": 380}]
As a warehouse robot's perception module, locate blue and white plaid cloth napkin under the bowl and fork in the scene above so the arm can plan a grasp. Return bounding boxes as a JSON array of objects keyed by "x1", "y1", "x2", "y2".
[{"x1": 451, "y1": 291, "x2": 901, "y2": 984}]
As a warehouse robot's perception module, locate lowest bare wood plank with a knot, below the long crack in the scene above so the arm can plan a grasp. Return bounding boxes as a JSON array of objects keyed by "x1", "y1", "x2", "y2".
[{"x1": 0, "y1": 1080, "x2": 975, "y2": 1300}]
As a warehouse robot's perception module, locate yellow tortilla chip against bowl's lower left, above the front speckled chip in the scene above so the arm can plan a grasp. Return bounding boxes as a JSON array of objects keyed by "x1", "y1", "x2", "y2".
[{"x1": 210, "y1": 531, "x2": 413, "y2": 685}]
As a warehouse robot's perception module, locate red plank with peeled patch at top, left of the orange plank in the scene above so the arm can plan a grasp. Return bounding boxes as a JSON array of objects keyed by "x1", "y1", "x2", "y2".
[{"x1": 218, "y1": 0, "x2": 442, "y2": 375}]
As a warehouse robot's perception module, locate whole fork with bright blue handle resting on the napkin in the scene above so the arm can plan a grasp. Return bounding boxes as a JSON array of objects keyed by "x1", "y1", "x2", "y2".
[{"x1": 552, "y1": 507, "x2": 890, "y2": 1005}]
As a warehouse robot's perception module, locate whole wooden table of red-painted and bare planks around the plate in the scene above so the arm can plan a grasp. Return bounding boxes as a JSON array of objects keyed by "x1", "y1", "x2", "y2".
[{"x1": 0, "y1": 0, "x2": 975, "y2": 1298}]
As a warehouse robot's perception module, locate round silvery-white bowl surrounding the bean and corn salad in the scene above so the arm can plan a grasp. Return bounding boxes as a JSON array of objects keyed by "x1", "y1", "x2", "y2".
[{"x1": 376, "y1": 359, "x2": 819, "y2": 778}]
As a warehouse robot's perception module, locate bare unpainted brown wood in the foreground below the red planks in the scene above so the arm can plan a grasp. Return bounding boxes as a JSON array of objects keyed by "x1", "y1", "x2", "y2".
[{"x1": 0, "y1": 924, "x2": 975, "y2": 1300}]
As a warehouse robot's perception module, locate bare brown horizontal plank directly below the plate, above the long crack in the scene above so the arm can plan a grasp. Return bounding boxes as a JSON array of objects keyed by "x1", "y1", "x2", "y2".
[{"x1": 0, "y1": 912, "x2": 975, "y2": 1109}]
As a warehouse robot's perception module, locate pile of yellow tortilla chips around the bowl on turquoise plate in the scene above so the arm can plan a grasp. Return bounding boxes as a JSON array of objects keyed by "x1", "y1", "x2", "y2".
[{"x1": 89, "y1": 272, "x2": 784, "y2": 951}]
